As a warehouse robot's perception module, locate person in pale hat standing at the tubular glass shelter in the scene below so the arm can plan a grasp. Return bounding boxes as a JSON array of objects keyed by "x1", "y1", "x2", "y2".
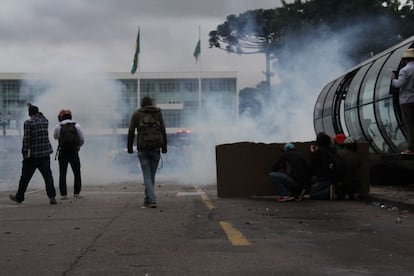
[{"x1": 391, "y1": 48, "x2": 414, "y2": 154}]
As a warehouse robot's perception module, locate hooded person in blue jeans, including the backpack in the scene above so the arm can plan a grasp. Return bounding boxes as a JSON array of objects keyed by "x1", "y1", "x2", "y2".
[{"x1": 127, "y1": 97, "x2": 167, "y2": 208}]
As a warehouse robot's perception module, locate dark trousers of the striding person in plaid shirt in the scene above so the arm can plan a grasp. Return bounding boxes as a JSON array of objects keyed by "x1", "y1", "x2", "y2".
[{"x1": 16, "y1": 156, "x2": 56, "y2": 201}]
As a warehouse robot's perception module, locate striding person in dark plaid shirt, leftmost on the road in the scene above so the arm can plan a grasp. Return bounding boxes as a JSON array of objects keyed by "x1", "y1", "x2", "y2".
[{"x1": 9, "y1": 103, "x2": 57, "y2": 204}]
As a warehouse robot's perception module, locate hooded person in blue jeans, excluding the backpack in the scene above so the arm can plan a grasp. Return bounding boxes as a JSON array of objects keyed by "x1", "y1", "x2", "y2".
[{"x1": 127, "y1": 97, "x2": 167, "y2": 208}]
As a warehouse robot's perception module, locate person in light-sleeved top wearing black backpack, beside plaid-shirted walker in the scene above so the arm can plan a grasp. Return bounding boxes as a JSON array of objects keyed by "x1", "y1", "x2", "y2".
[{"x1": 53, "y1": 109, "x2": 85, "y2": 200}]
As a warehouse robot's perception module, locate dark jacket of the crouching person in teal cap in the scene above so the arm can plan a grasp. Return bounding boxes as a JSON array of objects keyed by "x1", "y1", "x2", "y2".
[{"x1": 272, "y1": 150, "x2": 310, "y2": 188}]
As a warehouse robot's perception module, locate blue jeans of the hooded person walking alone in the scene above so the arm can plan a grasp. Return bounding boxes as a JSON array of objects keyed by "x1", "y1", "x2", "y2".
[{"x1": 138, "y1": 149, "x2": 161, "y2": 203}]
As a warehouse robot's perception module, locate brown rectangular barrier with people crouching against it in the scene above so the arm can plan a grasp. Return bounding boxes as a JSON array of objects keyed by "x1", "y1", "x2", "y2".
[{"x1": 216, "y1": 142, "x2": 369, "y2": 197}]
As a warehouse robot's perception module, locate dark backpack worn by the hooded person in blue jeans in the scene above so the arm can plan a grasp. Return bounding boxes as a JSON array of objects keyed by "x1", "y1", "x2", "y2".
[{"x1": 138, "y1": 111, "x2": 164, "y2": 149}]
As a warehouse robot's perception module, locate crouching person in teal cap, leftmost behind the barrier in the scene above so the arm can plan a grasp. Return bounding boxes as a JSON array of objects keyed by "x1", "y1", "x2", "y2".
[{"x1": 269, "y1": 143, "x2": 308, "y2": 202}]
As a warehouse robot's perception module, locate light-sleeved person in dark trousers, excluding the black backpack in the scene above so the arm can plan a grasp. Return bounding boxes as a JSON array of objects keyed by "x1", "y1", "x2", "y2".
[{"x1": 53, "y1": 109, "x2": 85, "y2": 200}]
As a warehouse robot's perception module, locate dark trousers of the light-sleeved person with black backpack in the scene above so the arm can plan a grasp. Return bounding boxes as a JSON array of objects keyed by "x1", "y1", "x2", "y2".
[{"x1": 58, "y1": 152, "x2": 82, "y2": 196}]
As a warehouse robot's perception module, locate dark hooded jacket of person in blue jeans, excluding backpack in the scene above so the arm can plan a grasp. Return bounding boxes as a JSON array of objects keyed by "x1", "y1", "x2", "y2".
[{"x1": 127, "y1": 106, "x2": 167, "y2": 153}]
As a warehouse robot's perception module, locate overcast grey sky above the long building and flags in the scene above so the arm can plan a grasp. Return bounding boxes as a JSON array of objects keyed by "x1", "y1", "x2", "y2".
[{"x1": 0, "y1": 0, "x2": 281, "y2": 88}]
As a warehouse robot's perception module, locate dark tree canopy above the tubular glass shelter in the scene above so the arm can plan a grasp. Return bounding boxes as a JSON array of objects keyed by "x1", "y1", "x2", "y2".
[{"x1": 209, "y1": 0, "x2": 414, "y2": 87}]
